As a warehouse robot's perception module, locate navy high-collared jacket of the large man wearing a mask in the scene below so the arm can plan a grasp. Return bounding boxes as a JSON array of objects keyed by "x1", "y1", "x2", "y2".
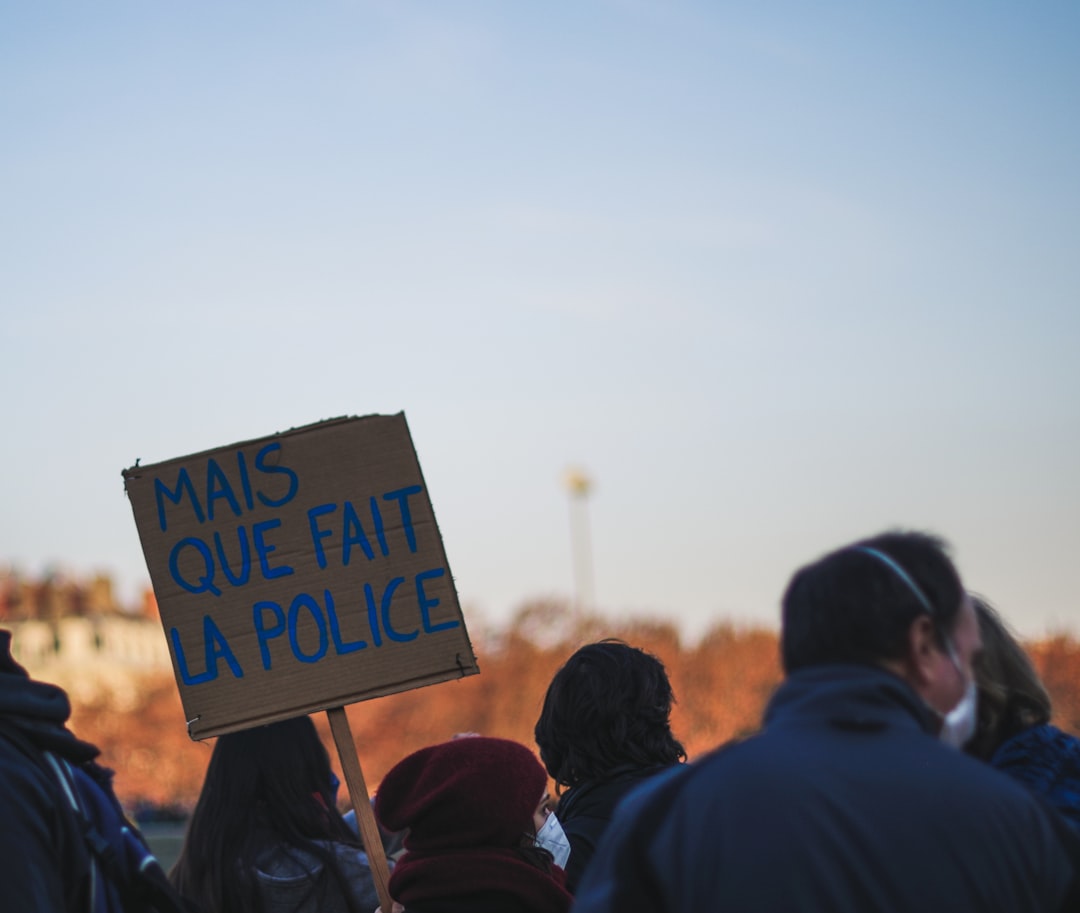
[{"x1": 575, "y1": 666, "x2": 1080, "y2": 913}]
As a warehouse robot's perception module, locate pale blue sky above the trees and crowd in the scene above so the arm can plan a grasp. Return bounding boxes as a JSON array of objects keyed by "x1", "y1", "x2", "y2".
[{"x1": 0, "y1": 0, "x2": 1080, "y2": 635}]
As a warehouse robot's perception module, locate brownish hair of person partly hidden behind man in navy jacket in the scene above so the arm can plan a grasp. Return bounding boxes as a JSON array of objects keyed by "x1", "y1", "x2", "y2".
[{"x1": 968, "y1": 594, "x2": 1052, "y2": 760}]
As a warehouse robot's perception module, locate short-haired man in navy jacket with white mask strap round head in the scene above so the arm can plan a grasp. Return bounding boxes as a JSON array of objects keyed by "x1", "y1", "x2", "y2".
[{"x1": 575, "y1": 533, "x2": 1080, "y2": 913}]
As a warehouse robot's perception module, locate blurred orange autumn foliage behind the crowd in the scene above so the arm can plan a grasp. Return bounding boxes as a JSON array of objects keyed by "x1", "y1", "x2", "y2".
[{"x1": 65, "y1": 602, "x2": 1080, "y2": 808}]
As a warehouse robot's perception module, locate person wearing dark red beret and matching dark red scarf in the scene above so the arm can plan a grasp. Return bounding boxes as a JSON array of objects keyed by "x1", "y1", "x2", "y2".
[{"x1": 375, "y1": 736, "x2": 570, "y2": 913}]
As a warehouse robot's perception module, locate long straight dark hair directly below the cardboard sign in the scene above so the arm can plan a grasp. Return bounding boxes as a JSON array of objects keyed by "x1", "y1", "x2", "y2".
[{"x1": 168, "y1": 716, "x2": 362, "y2": 913}]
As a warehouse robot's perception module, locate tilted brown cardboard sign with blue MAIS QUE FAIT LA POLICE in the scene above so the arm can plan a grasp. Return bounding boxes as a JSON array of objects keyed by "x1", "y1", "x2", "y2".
[{"x1": 123, "y1": 414, "x2": 480, "y2": 739}]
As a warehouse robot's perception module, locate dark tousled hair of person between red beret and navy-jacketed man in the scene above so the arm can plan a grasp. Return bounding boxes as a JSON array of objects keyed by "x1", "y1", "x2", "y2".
[{"x1": 535, "y1": 640, "x2": 686, "y2": 787}]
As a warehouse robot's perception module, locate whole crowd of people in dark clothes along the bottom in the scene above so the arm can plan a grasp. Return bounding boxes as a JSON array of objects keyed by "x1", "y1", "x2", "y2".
[{"x1": 0, "y1": 532, "x2": 1080, "y2": 913}]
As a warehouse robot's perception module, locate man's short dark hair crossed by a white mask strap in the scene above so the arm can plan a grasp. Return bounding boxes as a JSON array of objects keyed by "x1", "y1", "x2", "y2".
[{"x1": 781, "y1": 532, "x2": 964, "y2": 673}]
